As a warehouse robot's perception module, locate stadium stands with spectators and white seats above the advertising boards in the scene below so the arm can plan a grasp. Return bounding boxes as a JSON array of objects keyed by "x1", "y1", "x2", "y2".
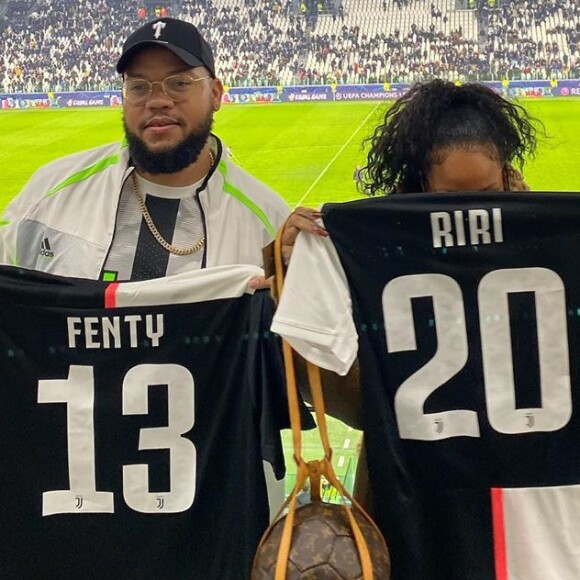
[{"x1": 0, "y1": 0, "x2": 580, "y2": 93}]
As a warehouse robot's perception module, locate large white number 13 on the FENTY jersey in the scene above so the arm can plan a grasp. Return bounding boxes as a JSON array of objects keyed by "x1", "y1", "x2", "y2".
[{"x1": 38, "y1": 364, "x2": 196, "y2": 516}]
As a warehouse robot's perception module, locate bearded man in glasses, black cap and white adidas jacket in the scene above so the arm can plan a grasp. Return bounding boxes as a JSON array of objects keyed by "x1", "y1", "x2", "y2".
[{"x1": 0, "y1": 18, "x2": 289, "y2": 281}]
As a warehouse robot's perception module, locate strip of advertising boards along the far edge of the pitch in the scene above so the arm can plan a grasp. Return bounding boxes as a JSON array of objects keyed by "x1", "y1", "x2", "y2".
[{"x1": 0, "y1": 79, "x2": 580, "y2": 110}]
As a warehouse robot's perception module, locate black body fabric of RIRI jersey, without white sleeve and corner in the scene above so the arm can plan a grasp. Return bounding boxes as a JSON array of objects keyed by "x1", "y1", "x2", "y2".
[{"x1": 323, "y1": 193, "x2": 580, "y2": 580}]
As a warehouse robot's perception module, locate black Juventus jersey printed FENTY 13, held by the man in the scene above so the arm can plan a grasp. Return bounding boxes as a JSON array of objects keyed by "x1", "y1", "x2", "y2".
[{"x1": 0, "y1": 266, "x2": 288, "y2": 580}]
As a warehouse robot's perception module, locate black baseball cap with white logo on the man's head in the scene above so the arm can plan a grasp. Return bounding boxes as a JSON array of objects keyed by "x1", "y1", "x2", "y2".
[{"x1": 117, "y1": 18, "x2": 215, "y2": 78}]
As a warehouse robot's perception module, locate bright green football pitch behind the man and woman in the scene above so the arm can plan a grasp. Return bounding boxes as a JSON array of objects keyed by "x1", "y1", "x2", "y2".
[{"x1": 0, "y1": 99, "x2": 580, "y2": 499}]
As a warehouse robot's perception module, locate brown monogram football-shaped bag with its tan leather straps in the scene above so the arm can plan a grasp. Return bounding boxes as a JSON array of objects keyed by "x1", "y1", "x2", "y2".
[{"x1": 252, "y1": 229, "x2": 390, "y2": 580}]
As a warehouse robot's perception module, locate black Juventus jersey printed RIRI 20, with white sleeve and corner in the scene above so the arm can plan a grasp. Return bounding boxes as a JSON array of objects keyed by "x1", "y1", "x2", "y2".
[{"x1": 272, "y1": 193, "x2": 580, "y2": 580}]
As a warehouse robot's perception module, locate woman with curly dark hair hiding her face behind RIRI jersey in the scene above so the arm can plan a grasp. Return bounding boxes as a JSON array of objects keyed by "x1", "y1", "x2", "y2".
[{"x1": 282, "y1": 79, "x2": 544, "y2": 509}]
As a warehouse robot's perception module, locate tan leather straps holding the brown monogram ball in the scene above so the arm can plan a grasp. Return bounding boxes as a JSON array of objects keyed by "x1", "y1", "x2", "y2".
[{"x1": 270, "y1": 228, "x2": 380, "y2": 580}]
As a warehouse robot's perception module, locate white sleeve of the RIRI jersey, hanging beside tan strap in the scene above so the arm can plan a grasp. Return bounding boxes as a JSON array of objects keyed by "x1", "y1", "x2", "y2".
[{"x1": 272, "y1": 234, "x2": 358, "y2": 375}]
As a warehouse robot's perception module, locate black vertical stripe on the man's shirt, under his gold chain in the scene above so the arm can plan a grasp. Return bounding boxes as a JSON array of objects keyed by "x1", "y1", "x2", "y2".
[{"x1": 131, "y1": 195, "x2": 180, "y2": 281}]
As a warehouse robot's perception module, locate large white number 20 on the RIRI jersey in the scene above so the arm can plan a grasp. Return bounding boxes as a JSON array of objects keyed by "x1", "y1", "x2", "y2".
[{"x1": 382, "y1": 268, "x2": 572, "y2": 441}]
